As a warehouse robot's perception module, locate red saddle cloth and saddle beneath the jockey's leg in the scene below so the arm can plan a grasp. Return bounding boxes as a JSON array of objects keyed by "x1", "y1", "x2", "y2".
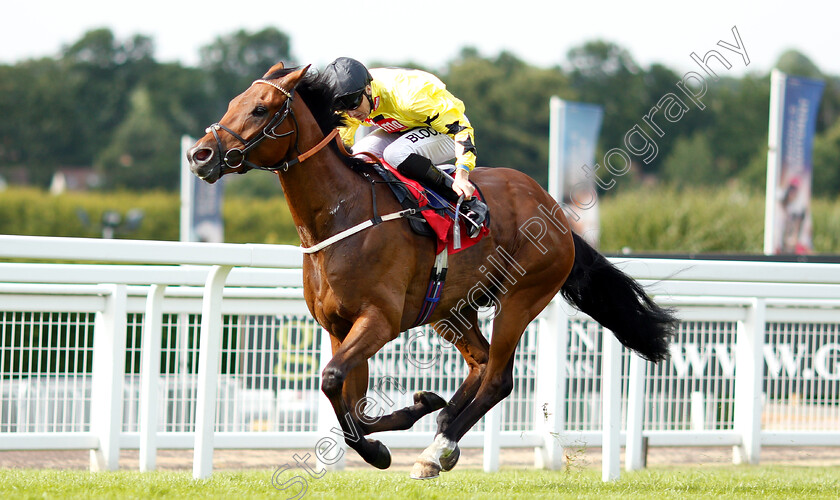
[{"x1": 360, "y1": 158, "x2": 490, "y2": 254}]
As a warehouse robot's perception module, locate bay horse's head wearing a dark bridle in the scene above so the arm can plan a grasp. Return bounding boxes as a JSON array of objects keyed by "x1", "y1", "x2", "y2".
[{"x1": 187, "y1": 63, "x2": 309, "y2": 184}]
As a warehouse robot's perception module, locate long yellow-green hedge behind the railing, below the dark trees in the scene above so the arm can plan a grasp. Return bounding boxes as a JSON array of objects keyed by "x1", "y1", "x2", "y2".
[{"x1": 0, "y1": 186, "x2": 840, "y2": 254}]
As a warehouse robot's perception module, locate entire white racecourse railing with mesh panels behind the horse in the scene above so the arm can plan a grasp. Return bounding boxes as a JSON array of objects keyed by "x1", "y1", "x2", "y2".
[{"x1": 0, "y1": 236, "x2": 840, "y2": 479}]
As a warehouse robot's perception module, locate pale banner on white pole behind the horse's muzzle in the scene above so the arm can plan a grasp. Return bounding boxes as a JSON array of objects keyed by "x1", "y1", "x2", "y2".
[{"x1": 181, "y1": 136, "x2": 225, "y2": 243}]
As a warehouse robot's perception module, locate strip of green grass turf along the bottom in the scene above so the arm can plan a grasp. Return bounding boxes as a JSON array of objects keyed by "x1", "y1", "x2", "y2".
[{"x1": 0, "y1": 466, "x2": 840, "y2": 500}]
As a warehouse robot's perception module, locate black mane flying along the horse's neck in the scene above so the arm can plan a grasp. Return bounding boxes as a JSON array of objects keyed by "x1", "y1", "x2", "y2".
[{"x1": 265, "y1": 68, "x2": 365, "y2": 169}]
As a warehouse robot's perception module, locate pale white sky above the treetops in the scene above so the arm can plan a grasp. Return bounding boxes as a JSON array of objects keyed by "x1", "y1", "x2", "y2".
[{"x1": 0, "y1": 0, "x2": 840, "y2": 76}]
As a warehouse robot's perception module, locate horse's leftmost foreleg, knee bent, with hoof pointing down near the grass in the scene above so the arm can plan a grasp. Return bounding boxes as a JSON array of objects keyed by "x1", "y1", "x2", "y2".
[{"x1": 321, "y1": 309, "x2": 395, "y2": 469}]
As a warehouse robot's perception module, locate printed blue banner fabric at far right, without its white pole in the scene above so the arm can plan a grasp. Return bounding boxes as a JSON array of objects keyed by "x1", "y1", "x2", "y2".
[{"x1": 773, "y1": 76, "x2": 825, "y2": 254}]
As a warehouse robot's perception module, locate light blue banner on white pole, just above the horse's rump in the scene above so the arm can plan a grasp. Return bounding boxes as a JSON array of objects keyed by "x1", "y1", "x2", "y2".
[{"x1": 548, "y1": 97, "x2": 604, "y2": 248}]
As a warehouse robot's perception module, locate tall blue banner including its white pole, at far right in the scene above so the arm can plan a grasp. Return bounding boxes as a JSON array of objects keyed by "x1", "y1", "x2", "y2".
[{"x1": 764, "y1": 70, "x2": 825, "y2": 255}]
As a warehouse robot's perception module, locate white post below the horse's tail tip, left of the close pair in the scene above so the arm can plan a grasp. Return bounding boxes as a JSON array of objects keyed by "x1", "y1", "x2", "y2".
[{"x1": 601, "y1": 328, "x2": 621, "y2": 481}]
